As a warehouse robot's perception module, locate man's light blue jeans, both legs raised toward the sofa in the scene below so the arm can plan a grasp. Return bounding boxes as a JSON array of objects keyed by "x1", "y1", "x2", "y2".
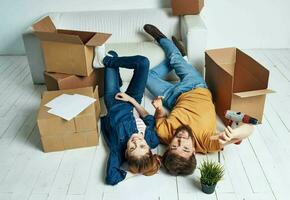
[{"x1": 146, "y1": 38, "x2": 207, "y2": 110}]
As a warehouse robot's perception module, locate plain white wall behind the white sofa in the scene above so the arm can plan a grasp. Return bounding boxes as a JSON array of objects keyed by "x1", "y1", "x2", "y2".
[{"x1": 0, "y1": 0, "x2": 290, "y2": 54}]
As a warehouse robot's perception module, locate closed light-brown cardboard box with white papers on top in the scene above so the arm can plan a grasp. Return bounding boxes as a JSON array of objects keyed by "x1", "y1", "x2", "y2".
[{"x1": 37, "y1": 87, "x2": 100, "y2": 152}]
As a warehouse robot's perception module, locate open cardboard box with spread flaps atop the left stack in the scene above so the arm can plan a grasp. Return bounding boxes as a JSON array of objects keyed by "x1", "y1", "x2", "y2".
[{"x1": 33, "y1": 17, "x2": 111, "y2": 76}]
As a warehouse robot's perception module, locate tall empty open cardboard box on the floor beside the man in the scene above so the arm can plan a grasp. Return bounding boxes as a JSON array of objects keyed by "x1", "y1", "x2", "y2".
[{"x1": 205, "y1": 48, "x2": 273, "y2": 124}]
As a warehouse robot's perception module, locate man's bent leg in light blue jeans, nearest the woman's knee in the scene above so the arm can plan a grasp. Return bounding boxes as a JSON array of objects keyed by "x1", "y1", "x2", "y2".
[{"x1": 146, "y1": 59, "x2": 173, "y2": 96}]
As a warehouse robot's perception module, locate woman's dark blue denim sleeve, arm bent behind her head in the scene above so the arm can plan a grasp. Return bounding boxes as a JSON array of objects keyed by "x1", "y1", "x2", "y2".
[{"x1": 106, "y1": 151, "x2": 127, "y2": 185}]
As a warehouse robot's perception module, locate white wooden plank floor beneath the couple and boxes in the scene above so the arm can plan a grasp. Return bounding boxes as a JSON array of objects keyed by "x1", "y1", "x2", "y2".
[{"x1": 0, "y1": 50, "x2": 290, "y2": 200}]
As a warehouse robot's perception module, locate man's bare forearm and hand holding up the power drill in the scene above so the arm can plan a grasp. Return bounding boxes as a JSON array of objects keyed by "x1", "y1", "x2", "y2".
[{"x1": 210, "y1": 124, "x2": 254, "y2": 148}]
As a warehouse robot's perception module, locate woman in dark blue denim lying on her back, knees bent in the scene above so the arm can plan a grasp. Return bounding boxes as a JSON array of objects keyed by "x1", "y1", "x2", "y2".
[{"x1": 101, "y1": 51, "x2": 160, "y2": 185}]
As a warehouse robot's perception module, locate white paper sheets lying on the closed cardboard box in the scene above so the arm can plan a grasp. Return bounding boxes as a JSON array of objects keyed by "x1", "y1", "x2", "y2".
[{"x1": 45, "y1": 94, "x2": 96, "y2": 121}]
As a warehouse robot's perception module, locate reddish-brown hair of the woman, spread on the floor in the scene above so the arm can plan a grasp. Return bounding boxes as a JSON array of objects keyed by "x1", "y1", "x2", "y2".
[{"x1": 126, "y1": 150, "x2": 161, "y2": 176}]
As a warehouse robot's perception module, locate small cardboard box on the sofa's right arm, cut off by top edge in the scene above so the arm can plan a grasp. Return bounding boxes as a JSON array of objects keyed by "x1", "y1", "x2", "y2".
[{"x1": 171, "y1": 0, "x2": 204, "y2": 16}]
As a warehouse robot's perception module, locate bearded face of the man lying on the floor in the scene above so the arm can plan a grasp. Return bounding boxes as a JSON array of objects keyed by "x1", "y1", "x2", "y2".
[{"x1": 169, "y1": 130, "x2": 195, "y2": 158}]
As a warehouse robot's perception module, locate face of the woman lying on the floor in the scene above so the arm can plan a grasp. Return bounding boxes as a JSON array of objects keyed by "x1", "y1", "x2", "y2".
[{"x1": 127, "y1": 133, "x2": 150, "y2": 157}]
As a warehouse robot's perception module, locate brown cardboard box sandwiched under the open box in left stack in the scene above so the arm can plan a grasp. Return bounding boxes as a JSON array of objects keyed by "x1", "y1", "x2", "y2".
[{"x1": 44, "y1": 68, "x2": 105, "y2": 97}]
